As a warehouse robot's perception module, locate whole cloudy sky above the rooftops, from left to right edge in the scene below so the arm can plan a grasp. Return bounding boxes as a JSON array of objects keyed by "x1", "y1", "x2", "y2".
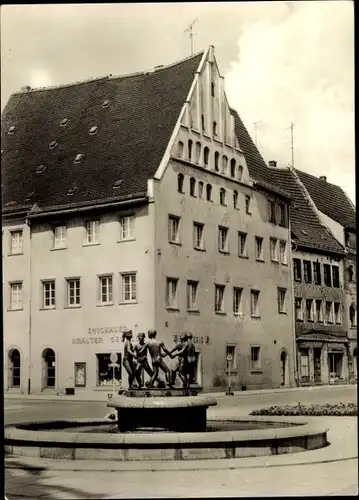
[{"x1": 1, "y1": 0, "x2": 355, "y2": 202}]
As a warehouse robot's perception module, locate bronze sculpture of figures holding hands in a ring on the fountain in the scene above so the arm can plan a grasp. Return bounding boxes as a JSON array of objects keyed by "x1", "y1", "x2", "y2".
[{"x1": 123, "y1": 330, "x2": 196, "y2": 389}]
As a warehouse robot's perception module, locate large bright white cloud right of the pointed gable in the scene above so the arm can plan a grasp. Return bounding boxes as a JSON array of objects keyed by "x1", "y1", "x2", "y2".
[{"x1": 224, "y1": 1, "x2": 355, "y2": 200}]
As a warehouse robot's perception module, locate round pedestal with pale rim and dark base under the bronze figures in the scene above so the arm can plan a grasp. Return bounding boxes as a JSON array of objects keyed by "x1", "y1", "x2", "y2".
[{"x1": 107, "y1": 395, "x2": 217, "y2": 432}]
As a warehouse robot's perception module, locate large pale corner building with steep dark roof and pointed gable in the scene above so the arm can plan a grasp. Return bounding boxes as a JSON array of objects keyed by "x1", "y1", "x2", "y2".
[{"x1": 1, "y1": 47, "x2": 298, "y2": 393}]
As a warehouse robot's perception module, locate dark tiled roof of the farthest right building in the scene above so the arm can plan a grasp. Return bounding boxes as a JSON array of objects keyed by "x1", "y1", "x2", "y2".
[{"x1": 296, "y1": 170, "x2": 356, "y2": 230}]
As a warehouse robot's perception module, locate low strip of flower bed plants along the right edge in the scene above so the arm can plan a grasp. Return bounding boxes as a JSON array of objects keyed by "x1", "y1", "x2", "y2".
[{"x1": 251, "y1": 402, "x2": 358, "y2": 417}]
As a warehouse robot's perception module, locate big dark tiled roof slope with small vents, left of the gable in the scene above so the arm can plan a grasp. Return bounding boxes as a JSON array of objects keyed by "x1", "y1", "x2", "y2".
[{"x1": 1, "y1": 52, "x2": 203, "y2": 213}]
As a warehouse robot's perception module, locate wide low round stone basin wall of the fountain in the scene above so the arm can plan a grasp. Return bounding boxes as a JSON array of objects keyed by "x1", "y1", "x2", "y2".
[{"x1": 4, "y1": 416, "x2": 328, "y2": 461}]
